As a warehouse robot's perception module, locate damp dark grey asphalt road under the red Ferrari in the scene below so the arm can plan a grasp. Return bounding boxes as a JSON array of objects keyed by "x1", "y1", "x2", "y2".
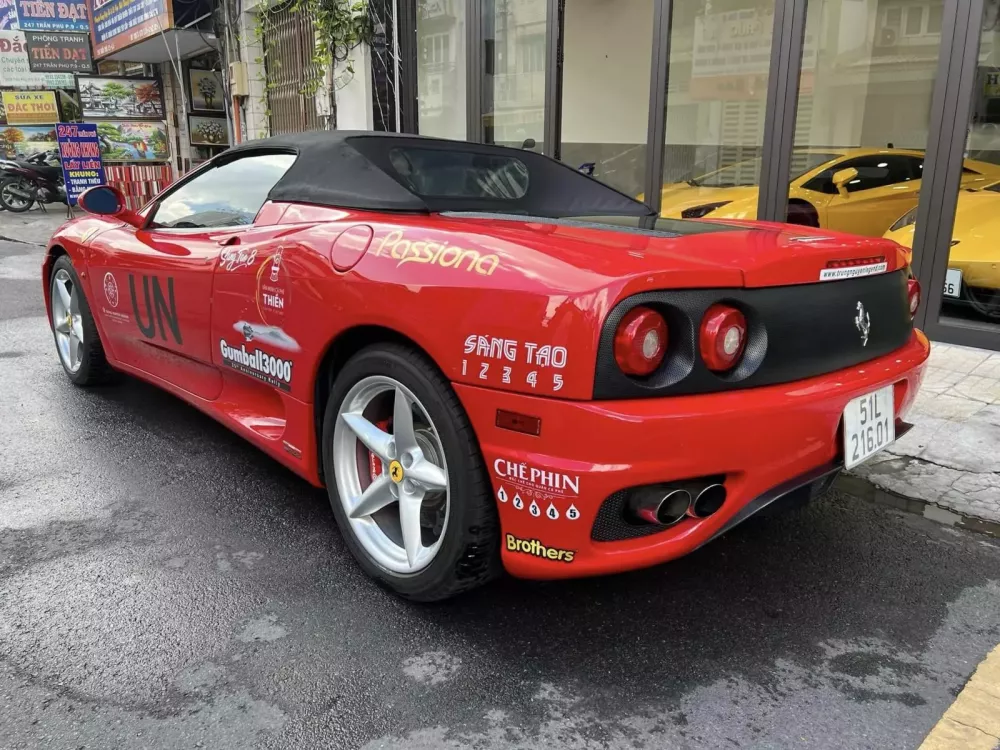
[{"x1": 0, "y1": 215, "x2": 1000, "y2": 750}]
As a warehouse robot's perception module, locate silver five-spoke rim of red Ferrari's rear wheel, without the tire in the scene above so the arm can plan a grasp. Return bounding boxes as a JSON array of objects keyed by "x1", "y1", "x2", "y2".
[{"x1": 333, "y1": 375, "x2": 451, "y2": 574}]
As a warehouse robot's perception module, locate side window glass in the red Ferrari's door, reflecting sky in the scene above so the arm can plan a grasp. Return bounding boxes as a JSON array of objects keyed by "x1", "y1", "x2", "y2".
[{"x1": 153, "y1": 154, "x2": 295, "y2": 229}]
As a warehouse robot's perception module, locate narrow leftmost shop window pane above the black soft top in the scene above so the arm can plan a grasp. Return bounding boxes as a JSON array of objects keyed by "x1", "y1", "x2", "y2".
[{"x1": 417, "y1": 0, "x2": 466, "y2": 140}]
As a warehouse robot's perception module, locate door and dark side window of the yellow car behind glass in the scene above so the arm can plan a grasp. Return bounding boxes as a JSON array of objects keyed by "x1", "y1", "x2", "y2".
[{"x1": 823, "y1": 154, "x2": 923, "y2": 237}]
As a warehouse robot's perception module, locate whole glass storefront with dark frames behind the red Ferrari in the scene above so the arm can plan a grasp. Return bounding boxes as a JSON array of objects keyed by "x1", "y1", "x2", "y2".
[{"x1": 410, "y1": 0, "x2": 1000, "y2": 349}]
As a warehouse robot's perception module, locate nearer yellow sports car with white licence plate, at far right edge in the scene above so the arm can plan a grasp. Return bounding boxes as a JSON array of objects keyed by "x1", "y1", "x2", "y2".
[{"x1": 885, "y1": 182, "x2": 1000, "y2": 320}]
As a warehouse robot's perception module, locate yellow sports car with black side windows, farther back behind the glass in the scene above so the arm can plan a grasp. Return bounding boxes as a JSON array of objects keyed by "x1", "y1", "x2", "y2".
[{"x1": 660, "y1": 148, "x2": 1000, "y2": 237}]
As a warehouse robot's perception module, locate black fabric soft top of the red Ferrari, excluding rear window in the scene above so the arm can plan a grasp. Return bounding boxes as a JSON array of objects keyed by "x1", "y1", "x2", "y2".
[{"x1": 216, "y1": 130, "x2": 650, "y2": 217}]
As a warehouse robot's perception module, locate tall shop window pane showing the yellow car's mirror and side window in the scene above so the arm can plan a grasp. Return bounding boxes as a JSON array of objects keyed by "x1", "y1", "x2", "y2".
[{"x1": 789, "y1": 0, "x2": 944, "y2": 237}]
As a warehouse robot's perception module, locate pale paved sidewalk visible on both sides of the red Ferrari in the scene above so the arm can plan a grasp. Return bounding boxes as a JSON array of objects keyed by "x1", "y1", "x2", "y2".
[{"x1": 0, "y1": 205, "x2": 1000, "y2": 536}]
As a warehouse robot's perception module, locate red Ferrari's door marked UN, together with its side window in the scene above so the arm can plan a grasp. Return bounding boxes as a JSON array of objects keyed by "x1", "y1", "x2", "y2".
[{"x1": 90, "y1": 152, "x2": 295, "y2": 399}]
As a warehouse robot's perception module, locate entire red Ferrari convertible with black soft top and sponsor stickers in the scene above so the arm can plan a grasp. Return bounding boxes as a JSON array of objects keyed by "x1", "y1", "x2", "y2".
[{"x1": 44, "y1": 132, "x2": 929, "y2": 600}]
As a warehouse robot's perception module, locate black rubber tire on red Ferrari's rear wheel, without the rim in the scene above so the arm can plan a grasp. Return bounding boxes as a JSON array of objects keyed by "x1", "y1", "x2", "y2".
[{"x1": 322, "y1": 344, "x2": 501, "y2": 602}]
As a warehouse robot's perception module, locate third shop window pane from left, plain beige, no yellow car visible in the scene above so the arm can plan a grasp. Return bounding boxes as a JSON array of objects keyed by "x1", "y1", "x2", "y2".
[{"x1": 560, "y1": 0, "x2": 653, "y2": 196}]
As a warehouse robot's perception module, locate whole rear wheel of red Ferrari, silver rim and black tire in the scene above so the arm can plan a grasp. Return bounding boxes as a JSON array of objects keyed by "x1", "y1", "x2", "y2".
[{"x1": 322, "y1": 343, "x2": 500, "y2": 601}]
